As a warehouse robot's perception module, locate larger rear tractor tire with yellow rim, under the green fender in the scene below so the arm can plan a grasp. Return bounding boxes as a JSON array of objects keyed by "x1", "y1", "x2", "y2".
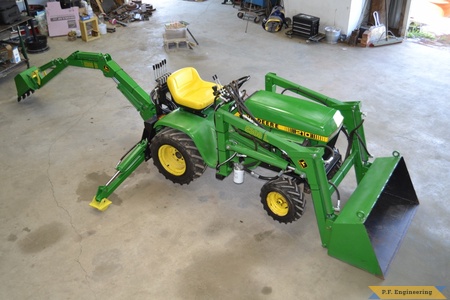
[{"x1": 150, "y1": 128, "x2": 206, "y2": 184}]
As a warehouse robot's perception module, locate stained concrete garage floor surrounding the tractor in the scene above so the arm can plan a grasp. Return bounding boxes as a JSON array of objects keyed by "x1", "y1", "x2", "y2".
[{"x1": 0, "y1": 0, "x2": 450, "y2": 299}]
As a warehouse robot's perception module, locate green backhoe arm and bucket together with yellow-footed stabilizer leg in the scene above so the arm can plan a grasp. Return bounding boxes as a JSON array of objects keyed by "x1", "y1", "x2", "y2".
[{"x1": 14, "y1": 51, "x2": 163, "y2": 211}]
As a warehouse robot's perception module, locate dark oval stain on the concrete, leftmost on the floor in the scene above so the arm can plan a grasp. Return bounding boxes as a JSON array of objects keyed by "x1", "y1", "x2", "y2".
[{"x1": 18, "y1": 222, "x2": 66, "y2": 253}]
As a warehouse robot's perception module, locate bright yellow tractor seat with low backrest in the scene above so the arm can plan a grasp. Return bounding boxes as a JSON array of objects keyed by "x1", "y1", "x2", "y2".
[{"x1": 167, "y1": 67, "x2": 217, "y2": 110}]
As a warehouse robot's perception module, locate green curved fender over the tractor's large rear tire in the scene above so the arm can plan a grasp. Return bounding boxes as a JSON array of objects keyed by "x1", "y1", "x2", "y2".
[{"x1": 155, "y1": 110, "x2": 217, "y2": 168}]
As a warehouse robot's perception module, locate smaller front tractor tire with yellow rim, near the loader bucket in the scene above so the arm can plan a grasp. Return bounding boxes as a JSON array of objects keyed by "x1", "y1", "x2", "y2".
[{"x1": 260, "y1": 177, "x2": 306, "y2": 223}]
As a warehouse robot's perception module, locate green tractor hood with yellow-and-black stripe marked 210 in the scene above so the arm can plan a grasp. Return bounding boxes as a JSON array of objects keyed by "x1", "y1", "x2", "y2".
[{"x1": 245, "y1": 90, "x2": 344, "y2": 143}]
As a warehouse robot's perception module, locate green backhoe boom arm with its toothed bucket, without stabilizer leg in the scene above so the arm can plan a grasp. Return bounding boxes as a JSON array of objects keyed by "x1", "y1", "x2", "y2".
[{"x1": 14, "y1": 51, "x2": 156, "y2": 121}]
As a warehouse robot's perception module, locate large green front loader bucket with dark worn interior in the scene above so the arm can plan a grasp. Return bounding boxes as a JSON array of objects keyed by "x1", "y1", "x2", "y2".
[{"x1": 328, "y1": 155, "x2": 419, "y2": 278}]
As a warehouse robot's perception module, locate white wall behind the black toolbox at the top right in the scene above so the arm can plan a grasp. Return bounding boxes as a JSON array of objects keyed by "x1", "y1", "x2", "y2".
[{"x1": 284, "y1": 0, "x2": 365, "y2": 35}]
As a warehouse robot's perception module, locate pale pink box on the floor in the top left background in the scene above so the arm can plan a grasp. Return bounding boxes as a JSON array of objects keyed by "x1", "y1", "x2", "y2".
[{"x1": 45, "y1": 2, "x2": 80, "y2": 36}]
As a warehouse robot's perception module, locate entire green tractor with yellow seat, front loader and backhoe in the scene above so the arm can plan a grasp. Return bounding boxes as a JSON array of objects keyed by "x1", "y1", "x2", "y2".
[{"x1": 15, "y1": 51, "x2": 419, "y2": 278}]
